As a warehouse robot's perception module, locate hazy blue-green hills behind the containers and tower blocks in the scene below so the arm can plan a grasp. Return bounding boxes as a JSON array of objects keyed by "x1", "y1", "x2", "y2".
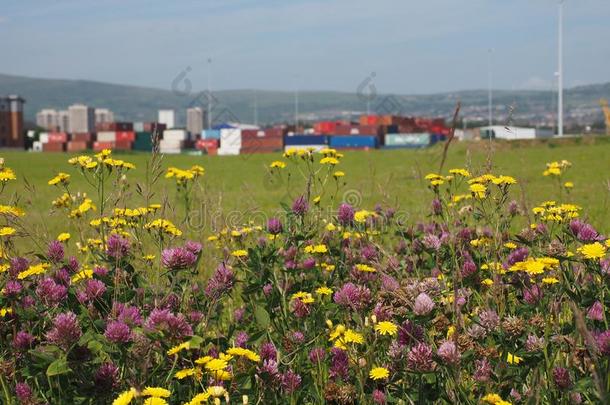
[{"x1": 0, "y1": 74, "x2": 610, "y2": 125}]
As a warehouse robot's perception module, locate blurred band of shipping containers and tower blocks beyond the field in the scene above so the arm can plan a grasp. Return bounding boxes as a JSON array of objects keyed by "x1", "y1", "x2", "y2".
[{"x1": 0, "y1": 95, "x2": 610, "y2": 155}]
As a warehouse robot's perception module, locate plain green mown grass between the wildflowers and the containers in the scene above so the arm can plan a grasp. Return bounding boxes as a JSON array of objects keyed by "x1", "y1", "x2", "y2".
[{"x1": 0, "y1": 138, "x2": 610, "y2": 236}]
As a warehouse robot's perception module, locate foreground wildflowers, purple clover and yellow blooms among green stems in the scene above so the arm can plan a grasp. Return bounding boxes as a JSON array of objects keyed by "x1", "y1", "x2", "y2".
[{"x1": 0, "y1": 144, "x2": 610, "y2": 405}]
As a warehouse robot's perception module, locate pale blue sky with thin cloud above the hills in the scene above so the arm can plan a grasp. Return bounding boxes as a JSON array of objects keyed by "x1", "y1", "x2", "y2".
[{"x1": 0, "y1": 0, "x2": 610, "y2": 94}]
